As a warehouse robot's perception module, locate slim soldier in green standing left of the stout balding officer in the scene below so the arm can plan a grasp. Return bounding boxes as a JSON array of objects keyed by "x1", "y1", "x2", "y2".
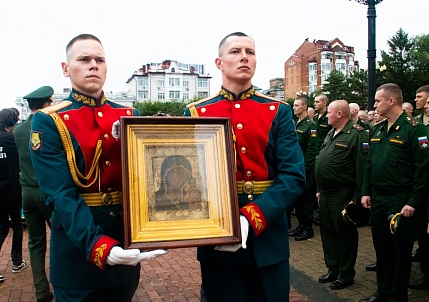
[{"x1": 288, "y1": 97, "x2": 318, "y2": 241}]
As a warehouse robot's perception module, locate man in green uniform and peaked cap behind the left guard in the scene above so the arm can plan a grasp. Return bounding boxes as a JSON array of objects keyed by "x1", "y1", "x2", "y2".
[{"x1": 13, "y1": 86, "x2": 54, "y2": 302}]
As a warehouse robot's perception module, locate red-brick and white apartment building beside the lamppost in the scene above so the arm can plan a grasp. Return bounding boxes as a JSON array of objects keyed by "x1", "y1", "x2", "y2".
[{"x1": 284, "y1": 38, "x2": 359, "y2": 99}]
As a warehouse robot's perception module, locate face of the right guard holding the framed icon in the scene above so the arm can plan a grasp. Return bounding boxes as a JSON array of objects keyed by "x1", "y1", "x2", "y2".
[{"x1": 216, "y1": 36, "x2": 256, "y2": 85}]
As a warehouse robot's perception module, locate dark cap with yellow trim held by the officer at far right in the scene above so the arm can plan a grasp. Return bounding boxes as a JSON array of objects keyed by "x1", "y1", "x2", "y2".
[{"x1": 387, "y1": 212, "x2": 426, "y2": 241}]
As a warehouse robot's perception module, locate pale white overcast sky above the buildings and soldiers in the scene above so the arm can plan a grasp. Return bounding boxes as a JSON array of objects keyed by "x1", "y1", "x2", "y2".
[{"x1": 0, "y1": 0, "x2": 429, "y2": 108}]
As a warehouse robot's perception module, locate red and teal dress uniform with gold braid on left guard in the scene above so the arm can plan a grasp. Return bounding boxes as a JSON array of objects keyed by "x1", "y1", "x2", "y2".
[{"x1": 31, "y1": 89, "x2": 140, "y2": 301}]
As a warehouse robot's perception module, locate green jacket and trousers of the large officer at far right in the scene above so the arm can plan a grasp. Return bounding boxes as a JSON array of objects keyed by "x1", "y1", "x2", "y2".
[{"x1": 362, "y1": 112, "x2": 429, "y2": 301}]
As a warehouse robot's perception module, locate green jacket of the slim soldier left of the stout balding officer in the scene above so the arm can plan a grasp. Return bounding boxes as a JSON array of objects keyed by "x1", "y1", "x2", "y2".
[{"x1": 296, "y1": 115, "x2": 319, "y2": 171}]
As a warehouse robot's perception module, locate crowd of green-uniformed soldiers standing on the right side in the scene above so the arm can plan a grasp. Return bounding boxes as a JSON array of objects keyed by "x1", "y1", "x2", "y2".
[{"x1": 287, "y1": 84, "x2": 429, "y2": 302}]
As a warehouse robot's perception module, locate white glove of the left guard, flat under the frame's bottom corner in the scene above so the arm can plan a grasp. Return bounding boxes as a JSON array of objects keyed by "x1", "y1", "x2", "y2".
[{"x1": 106, "y1": 246, "x2": 167, "y2": 266}]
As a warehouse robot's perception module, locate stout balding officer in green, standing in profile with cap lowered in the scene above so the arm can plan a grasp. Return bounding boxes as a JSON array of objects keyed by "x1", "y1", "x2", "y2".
[{"x1": 315, "y1": 100, "x2": 368, "y2": 290}]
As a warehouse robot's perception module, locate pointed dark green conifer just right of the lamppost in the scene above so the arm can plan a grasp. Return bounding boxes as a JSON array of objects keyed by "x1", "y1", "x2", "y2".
[{"x1": 377, "y1": 28, "x2": 417, "y2": 100}]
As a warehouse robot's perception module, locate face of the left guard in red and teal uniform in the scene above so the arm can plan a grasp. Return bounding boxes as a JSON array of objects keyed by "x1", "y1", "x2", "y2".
[{"x1": 62, "y1": 39, "x2": 107, "y2": 98}]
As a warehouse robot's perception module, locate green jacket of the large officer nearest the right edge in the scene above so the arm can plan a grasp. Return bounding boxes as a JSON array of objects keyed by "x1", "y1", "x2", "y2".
[{"x1": 362, "y1": 112, "x2": 429, "y2": 208}]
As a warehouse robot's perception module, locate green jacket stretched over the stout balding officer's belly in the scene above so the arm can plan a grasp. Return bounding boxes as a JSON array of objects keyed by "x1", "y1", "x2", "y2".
[{"x1": 315, "y1": 120, "x2": 369, "y2": 202}]
